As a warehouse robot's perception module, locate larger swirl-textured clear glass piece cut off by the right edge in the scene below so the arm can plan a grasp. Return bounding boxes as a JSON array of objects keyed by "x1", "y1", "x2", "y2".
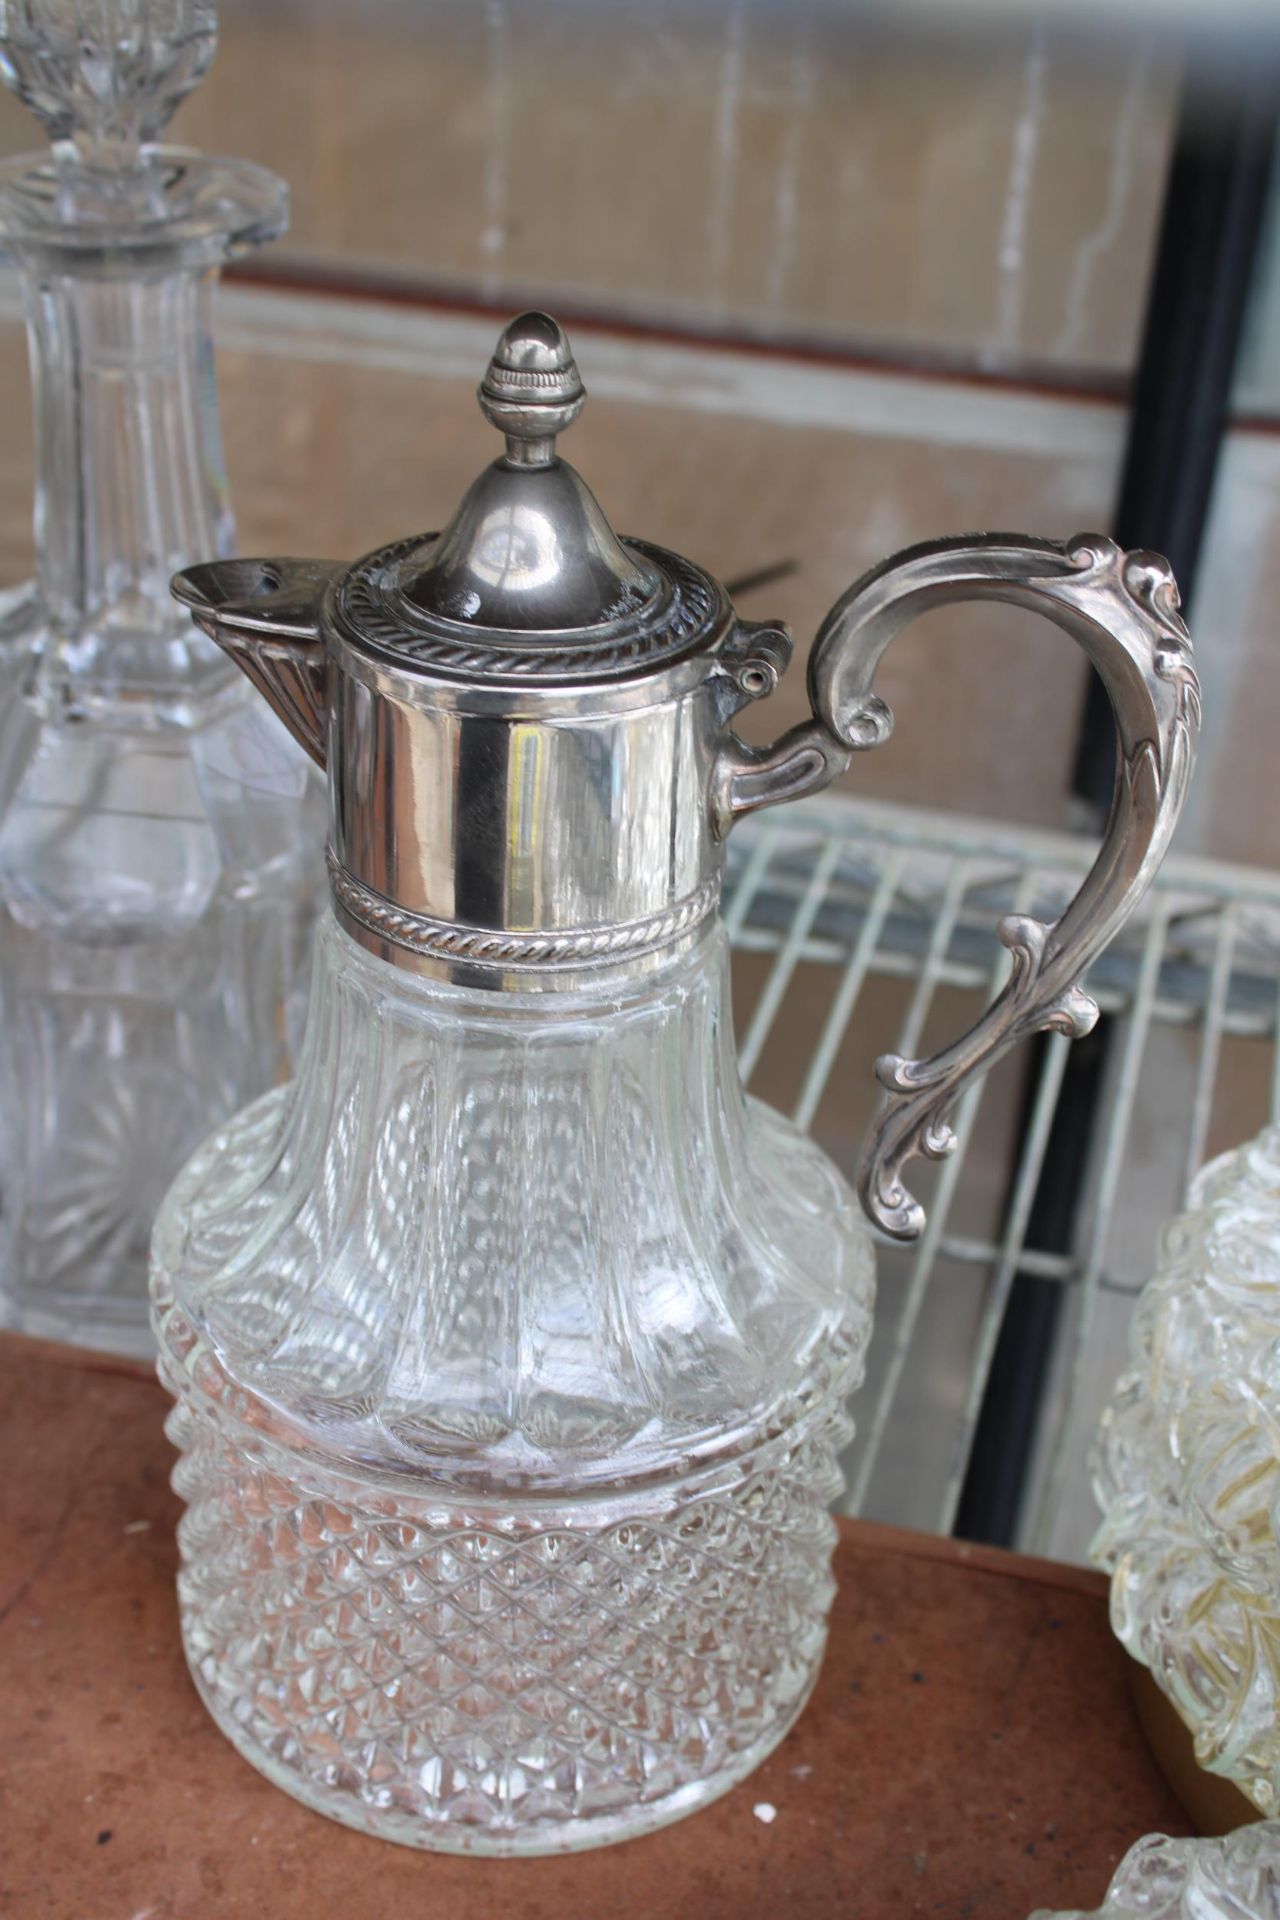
[{"x1": 1090, "y1": 1127, "x2": 1280, "y2": 1816}]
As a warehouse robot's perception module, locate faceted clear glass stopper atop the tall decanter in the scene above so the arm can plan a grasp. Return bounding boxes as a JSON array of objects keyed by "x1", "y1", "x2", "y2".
[{"x1": 0, "y1": 0, "x2": 217, "y2": 167}]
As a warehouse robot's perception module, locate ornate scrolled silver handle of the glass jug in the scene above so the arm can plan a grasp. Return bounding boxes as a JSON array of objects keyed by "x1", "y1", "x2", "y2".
[{"x1": 712, "y1": 534, "x2": 1199, "y2": 1240}]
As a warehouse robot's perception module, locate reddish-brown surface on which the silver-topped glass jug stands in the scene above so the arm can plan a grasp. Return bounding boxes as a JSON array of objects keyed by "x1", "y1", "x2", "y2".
[{"x1": 0, "y1": 1336, "x2": 1186, "y2": 1920}]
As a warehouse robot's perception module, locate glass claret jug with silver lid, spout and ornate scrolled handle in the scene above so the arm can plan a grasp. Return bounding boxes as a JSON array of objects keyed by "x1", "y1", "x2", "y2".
[{"x1": 152, "y1": 313, "x2": 1197, "y2": 1853}]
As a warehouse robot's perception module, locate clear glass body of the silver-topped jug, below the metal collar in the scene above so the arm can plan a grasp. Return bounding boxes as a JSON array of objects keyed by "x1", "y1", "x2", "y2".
[{"x1": 154, "y1": 925, "x2": 873, "y2": 1853}]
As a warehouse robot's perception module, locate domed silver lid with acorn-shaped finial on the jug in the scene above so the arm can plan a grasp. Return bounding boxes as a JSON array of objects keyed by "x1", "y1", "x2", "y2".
[{"x1": 330, "y1": 313, "x2": 729, "y2": 682}]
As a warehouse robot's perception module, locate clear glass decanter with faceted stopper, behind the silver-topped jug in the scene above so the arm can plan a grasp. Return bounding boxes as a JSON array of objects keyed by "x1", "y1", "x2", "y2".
[{"x1": 0, "y1": 0, "x2": 324, "y2": 1352}]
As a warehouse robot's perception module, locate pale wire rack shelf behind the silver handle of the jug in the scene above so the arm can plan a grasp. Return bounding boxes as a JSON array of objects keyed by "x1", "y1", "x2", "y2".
[{"x1": 725, "y1": 799, "x2": 1280, "y2": 1557}]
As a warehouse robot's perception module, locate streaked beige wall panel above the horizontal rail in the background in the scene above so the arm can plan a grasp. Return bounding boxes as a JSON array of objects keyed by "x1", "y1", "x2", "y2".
[{"x1": 0, "y1": 0, "x2": 1171, "y2": 372}]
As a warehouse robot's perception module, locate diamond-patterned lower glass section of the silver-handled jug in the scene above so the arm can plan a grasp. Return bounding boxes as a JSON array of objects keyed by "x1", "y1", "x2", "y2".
[{"x1": 175, "y1": 1415, "x2": 848, "y2": 1851}]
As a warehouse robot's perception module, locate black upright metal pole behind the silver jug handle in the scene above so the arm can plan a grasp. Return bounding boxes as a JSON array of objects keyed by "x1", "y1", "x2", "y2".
[{"x1": 956, "y1": 46, "x2": 1280, "y2": 1546}]
